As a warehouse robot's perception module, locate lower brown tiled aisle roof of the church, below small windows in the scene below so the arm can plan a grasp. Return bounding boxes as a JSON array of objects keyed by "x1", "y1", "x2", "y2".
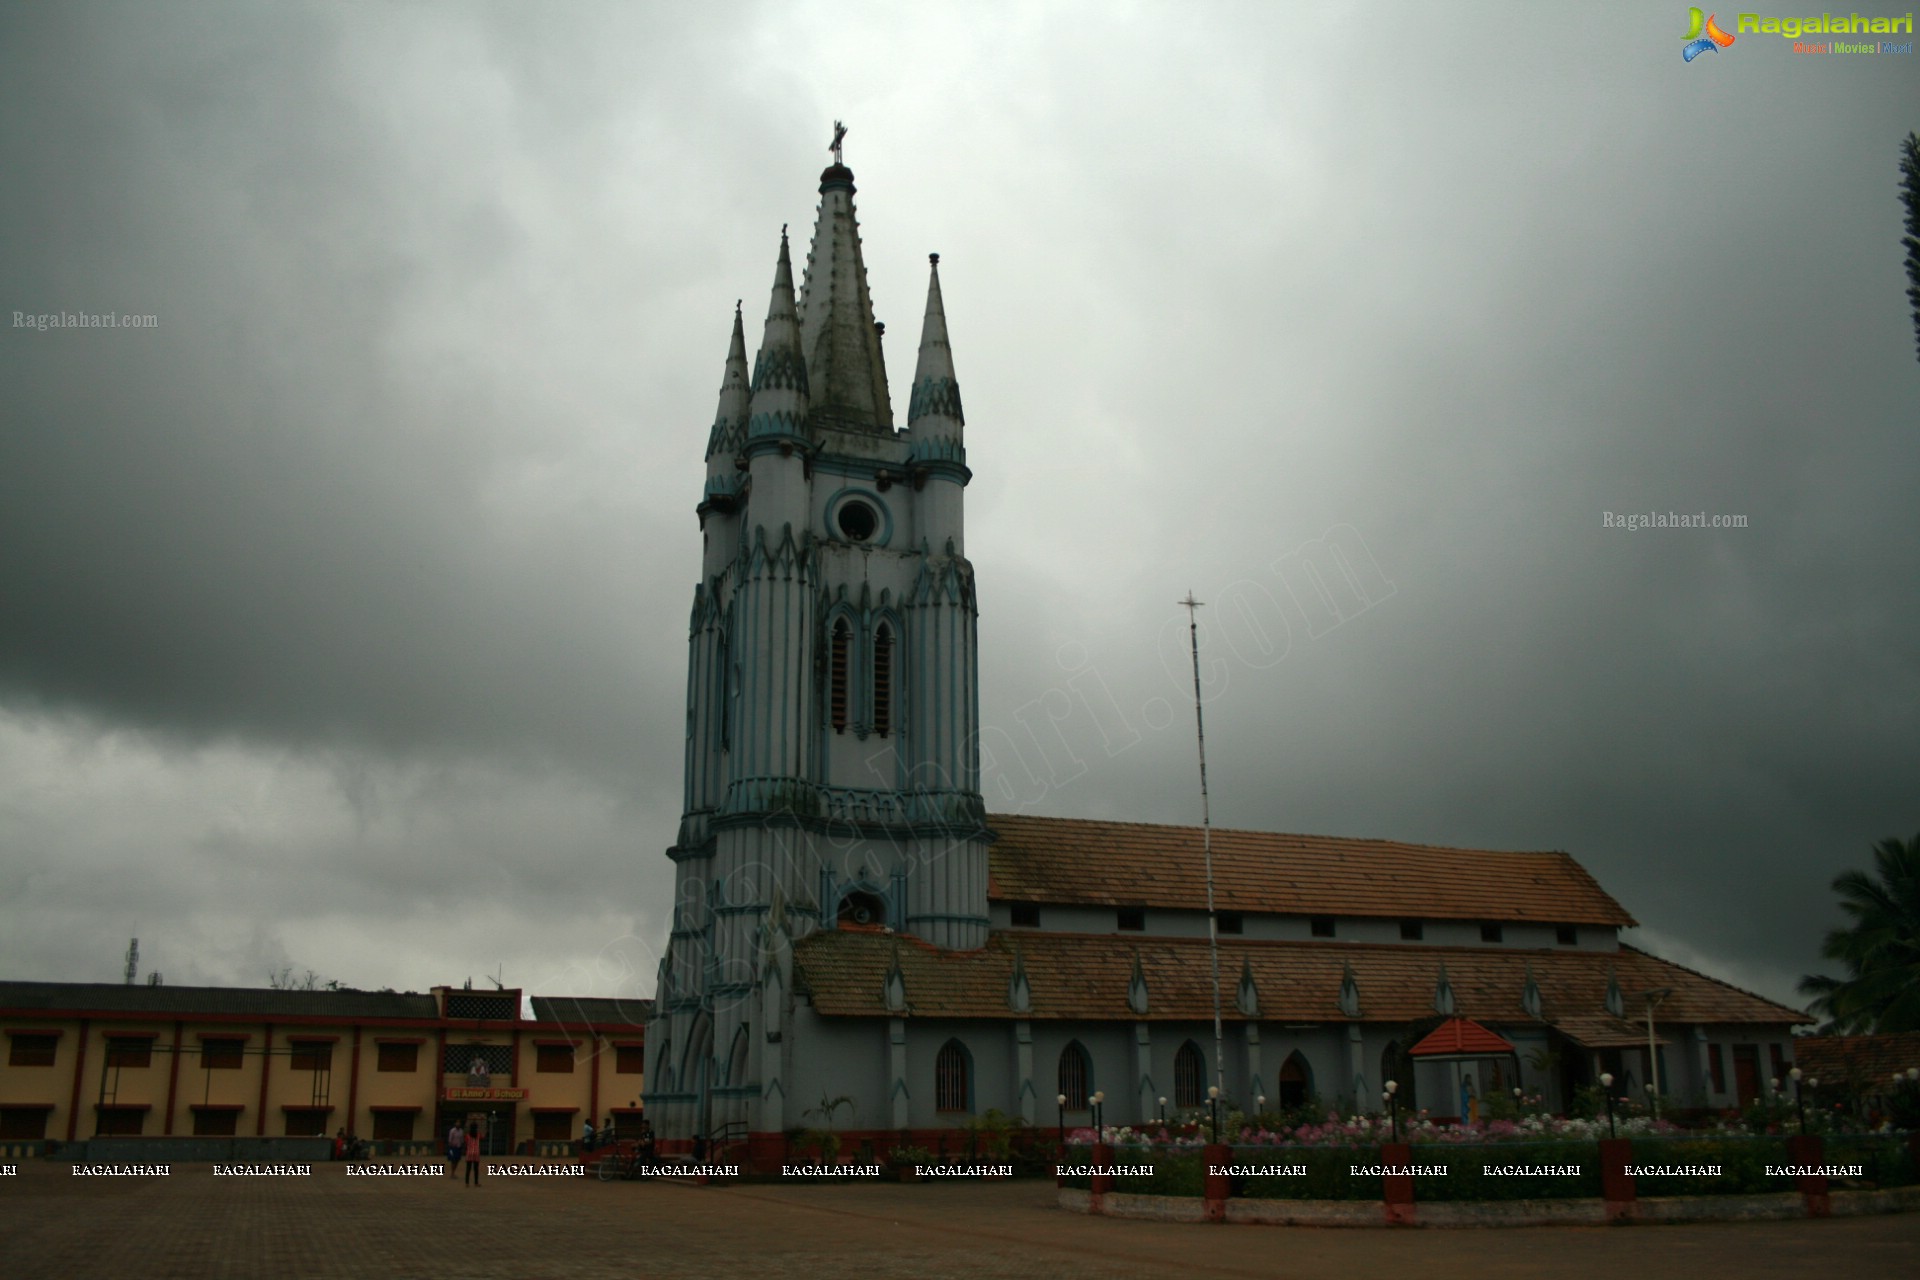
[{"x1": 795, "y1": 929, "x2": 1811, "y2": 1029}]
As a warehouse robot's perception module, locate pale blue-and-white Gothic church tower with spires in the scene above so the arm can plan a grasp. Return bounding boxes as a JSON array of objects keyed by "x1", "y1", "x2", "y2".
[{"x1": 645, "y1": 129, "x2": 987, "y2": 1140}]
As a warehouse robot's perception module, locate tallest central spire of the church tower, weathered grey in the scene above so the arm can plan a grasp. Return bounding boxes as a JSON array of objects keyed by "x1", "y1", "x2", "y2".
[{"x1": 801, "y1": 159, "x2": 893, "y2": 432}]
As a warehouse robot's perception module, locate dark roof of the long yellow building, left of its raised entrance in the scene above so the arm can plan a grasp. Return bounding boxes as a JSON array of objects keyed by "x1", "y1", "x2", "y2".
[{"x1": 0, "y1": 983, "x2": 440, "y2": 1019}]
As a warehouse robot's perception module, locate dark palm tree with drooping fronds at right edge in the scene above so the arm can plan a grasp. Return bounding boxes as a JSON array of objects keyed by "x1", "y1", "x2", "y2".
[{"x1": 1799, "y1": 835, "x2": 1920, "y2": 1034}]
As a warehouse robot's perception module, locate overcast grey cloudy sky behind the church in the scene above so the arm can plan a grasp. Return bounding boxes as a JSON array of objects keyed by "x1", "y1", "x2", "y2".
[{"x1": 0, "y1": 0, "x2": 1920, "y2": 1004}]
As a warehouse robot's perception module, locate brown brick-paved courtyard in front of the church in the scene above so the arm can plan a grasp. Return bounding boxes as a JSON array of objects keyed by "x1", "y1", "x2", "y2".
[{"x1": 0, "y1": 1163, "x2": 1920, "y2": 1280}]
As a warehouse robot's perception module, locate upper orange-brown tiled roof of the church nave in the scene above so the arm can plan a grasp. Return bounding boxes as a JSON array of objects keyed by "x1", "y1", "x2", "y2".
[{"x1": 987, "y1": 814, "x2": 1636, "y2": 925}]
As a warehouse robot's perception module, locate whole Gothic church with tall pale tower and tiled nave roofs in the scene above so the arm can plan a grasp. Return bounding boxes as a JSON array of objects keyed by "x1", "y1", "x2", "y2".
[{"x1": 645, "y1": 142, "x2": 1811, "y2": 1163}]
